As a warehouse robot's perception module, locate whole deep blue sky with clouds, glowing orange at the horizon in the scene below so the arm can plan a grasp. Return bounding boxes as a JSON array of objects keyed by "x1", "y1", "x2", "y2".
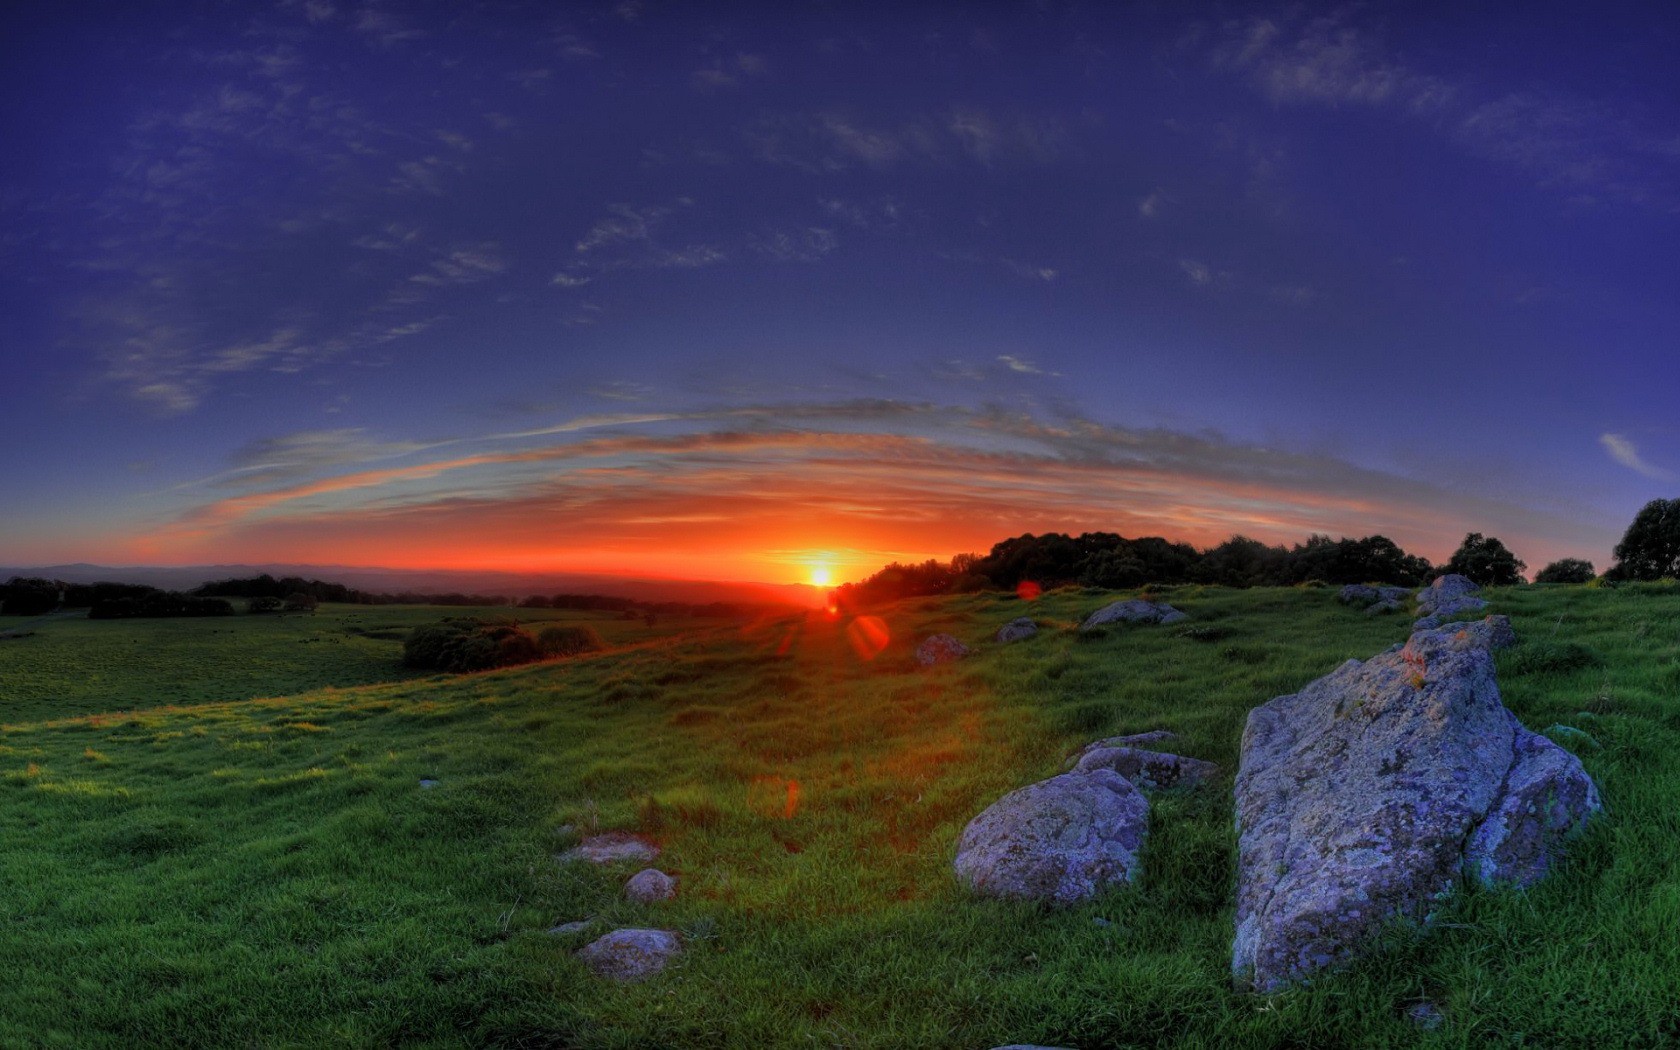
[{"x1": 0, "y1": 0, "x2": 1680, "y2": 583}]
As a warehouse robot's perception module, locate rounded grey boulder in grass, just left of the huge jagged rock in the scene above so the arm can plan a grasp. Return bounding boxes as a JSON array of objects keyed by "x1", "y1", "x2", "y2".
[{"x1": 956, "y1": 769, "x2": 1149, "y2": 904}]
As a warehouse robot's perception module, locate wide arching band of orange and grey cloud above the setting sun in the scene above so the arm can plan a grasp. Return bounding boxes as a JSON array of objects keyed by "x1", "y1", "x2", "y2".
[{"x1": 150, "y1": 396, "x2": 1598, "y2": 578}]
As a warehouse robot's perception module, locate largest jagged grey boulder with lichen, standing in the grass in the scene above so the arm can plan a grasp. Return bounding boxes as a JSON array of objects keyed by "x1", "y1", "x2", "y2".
[{"x1": 1231, "y1": 617, "x2": 1599, "y2": 991}]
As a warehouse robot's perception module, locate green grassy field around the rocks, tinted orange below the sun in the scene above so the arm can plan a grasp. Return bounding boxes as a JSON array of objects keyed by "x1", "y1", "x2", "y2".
[{"x1": 0, "y1": 585, "x2": 1680, "y2": 1048}]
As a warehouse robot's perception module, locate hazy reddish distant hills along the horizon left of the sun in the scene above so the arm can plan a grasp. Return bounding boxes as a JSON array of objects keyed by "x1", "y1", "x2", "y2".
[{"x1": 0, "y1": 563, "x2": 827, "y2": 608}]
